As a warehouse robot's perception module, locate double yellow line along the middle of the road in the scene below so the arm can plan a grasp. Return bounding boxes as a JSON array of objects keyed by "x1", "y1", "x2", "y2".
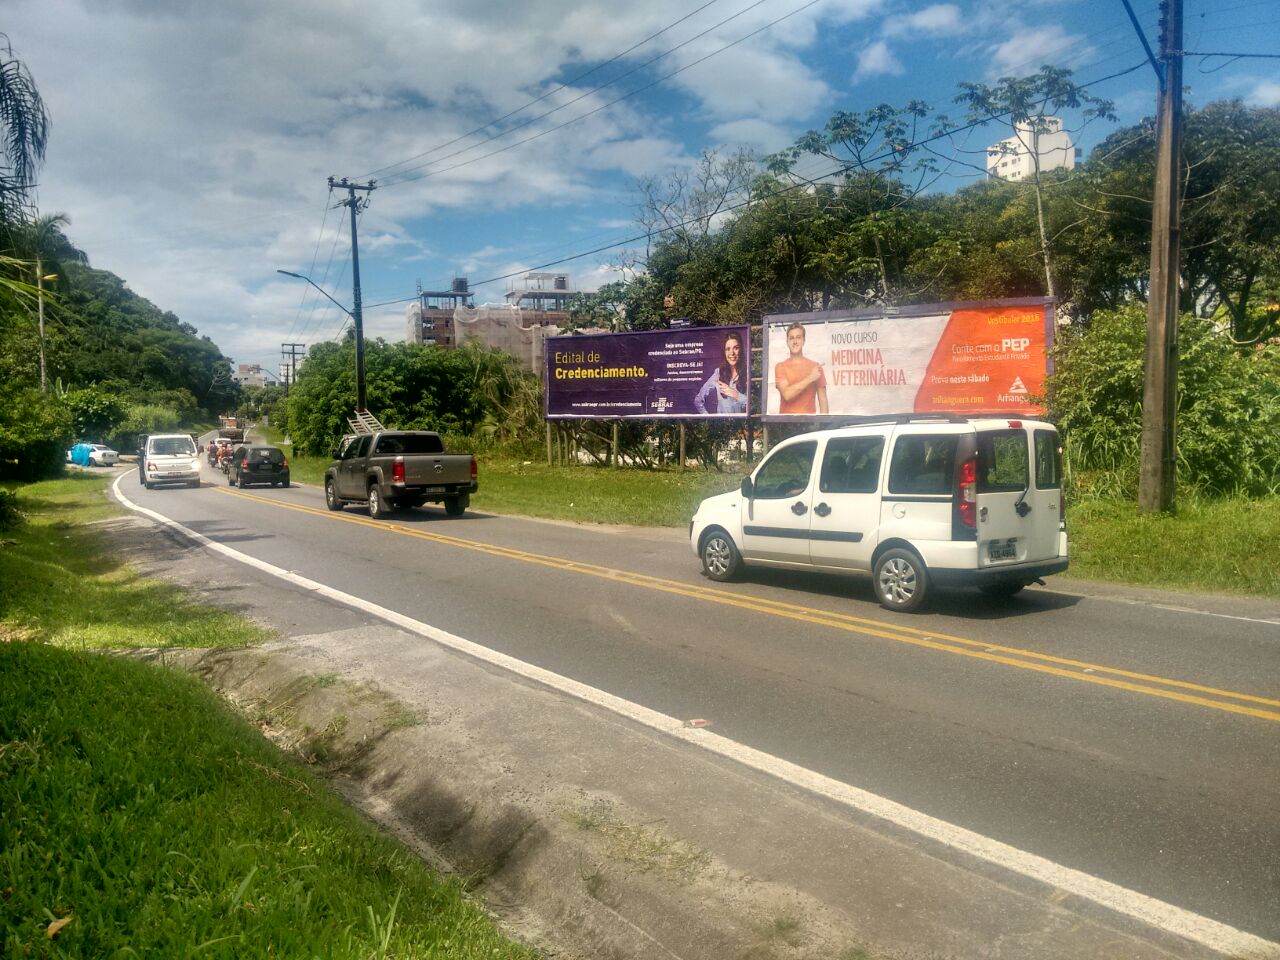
[{"x1": 215, "y1": 488, "x2": 1280, "y2": 721}]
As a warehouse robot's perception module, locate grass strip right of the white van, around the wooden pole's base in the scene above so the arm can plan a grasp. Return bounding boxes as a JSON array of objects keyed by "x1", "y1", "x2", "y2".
[{"x1": 1066, "y1": 498, "x2": 1280, "y2": 598}]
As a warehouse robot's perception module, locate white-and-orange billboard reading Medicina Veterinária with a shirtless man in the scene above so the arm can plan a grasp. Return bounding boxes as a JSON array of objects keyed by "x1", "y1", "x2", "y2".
[{"x1": 763, "y1": 298, "x2": 1053, "y2": 420}]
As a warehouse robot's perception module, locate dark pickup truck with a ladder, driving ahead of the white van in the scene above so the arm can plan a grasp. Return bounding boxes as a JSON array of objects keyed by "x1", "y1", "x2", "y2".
[{"x1": 324, "y1": 430, "x2": 479, "y2": 518}]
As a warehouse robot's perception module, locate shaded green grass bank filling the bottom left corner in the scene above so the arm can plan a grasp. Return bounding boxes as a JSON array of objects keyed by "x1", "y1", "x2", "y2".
[{"x1": 0, "y1": 643, "x2": 534, "y2": 960}]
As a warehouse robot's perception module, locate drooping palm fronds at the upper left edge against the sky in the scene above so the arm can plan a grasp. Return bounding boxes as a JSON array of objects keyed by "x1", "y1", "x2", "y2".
[{"x1": 0, "y1": 33, "x2": 49, "y2": 223}]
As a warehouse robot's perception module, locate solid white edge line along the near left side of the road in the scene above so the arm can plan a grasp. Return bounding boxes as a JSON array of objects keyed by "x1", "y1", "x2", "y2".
[{"x1": 113, "y1": 474, "x2": 1280, "y2": 960}]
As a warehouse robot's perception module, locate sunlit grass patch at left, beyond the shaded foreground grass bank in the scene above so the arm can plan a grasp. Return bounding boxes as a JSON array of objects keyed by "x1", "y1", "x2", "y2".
[{"x1": 0, "y1": 475, "x2": 265, "y2": 649}]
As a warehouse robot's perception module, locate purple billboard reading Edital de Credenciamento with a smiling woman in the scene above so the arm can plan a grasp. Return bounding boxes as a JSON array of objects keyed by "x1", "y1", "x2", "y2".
[{"x1": 545, "y1": 326, "x2": 751, "y2": 420}]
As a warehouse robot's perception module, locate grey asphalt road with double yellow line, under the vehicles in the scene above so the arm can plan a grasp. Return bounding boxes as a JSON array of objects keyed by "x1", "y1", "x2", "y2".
[{"x1": 117, "y1": 467, "x2": 1280, "y2": 940}]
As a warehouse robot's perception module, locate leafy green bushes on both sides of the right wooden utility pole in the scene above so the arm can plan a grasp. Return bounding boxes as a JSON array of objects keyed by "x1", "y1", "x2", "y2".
[{"x1": 1048, "y1": 305, "x2": 1280, "y2": 498}]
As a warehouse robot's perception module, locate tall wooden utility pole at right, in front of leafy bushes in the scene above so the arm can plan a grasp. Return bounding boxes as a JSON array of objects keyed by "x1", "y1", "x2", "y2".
[{"x1": 1138, "y1": 0, "x2": 1183, "y2": 513}]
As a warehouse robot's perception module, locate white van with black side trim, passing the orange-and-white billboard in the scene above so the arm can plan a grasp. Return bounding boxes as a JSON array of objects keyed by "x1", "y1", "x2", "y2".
[{"x1": 689, "y1": 416, "x2": 1068, "y2": 611}]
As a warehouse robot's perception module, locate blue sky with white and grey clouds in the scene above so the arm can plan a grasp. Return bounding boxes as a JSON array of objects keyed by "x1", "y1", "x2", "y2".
[{"x1": 10, "y1": 0, "x2": 1280, "y2": 371}]
